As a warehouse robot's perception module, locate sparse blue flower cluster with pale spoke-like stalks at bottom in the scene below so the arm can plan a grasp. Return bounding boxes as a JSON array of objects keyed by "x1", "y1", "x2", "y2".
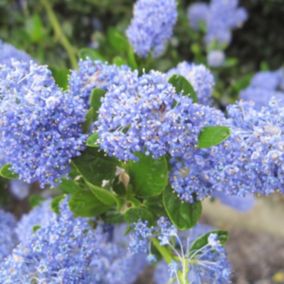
[{"x1": 130, "y1": 217, "x2": 231, "y2": 284}]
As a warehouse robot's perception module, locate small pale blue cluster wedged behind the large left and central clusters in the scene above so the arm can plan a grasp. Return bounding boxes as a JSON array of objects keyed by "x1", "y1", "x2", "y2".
[{"x1": 69, "y1": 59, "x2": 130, "y2": 108}]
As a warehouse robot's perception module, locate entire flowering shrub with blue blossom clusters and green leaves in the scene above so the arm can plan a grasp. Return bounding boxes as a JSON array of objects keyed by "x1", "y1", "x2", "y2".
[{"x1": 0, "y1": 0, "x2": 284, "y2": 284}]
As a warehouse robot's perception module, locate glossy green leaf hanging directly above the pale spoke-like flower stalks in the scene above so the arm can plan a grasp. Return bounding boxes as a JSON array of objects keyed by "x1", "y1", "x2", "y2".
[{"x1": 163, "y1": 187, "x2": 202, "y2": 230}]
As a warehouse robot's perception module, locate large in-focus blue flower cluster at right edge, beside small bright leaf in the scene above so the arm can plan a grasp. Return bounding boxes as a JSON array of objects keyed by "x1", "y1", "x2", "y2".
[{"x1": 204, "y1": 100, "x2": 284, "y2": 196}]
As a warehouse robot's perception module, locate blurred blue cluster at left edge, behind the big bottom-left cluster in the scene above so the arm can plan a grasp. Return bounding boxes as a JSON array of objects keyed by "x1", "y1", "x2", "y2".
[{"x1": 0, "y1": 209, "x2": 18, "y2": 261}]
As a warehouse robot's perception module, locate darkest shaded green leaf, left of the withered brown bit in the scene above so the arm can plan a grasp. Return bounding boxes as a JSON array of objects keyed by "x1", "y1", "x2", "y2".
[{"x1": 73, "y1": 148, "x2": 118, "y2": 186}]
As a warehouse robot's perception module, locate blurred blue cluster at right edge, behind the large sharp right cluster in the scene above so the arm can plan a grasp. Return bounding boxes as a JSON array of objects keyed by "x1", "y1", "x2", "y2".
[{"x1": 240, "y1": 69, "x2": 284, "y2": 109}]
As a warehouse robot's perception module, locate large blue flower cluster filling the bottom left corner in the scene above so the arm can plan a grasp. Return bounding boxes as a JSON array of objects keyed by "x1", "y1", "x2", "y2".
[{"x1": 0, "y1": 199, "x2": 146, "y2": 284}]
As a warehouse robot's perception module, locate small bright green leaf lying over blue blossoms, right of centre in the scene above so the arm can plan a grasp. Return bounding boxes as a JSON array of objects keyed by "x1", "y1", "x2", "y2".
[{"x1": 198, "y1": 126, "x2": 231, "y2": 148}]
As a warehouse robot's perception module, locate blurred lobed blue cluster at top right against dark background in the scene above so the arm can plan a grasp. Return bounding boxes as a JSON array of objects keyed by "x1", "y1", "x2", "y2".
[{"x1": 188, "y1": 0, "x2": 247, "y2": 47}]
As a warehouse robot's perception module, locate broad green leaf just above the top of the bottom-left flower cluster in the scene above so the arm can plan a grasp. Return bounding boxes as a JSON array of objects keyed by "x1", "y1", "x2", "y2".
[{"x1": 69, "y1": 190, "x2": 109, "y2": 217}]
